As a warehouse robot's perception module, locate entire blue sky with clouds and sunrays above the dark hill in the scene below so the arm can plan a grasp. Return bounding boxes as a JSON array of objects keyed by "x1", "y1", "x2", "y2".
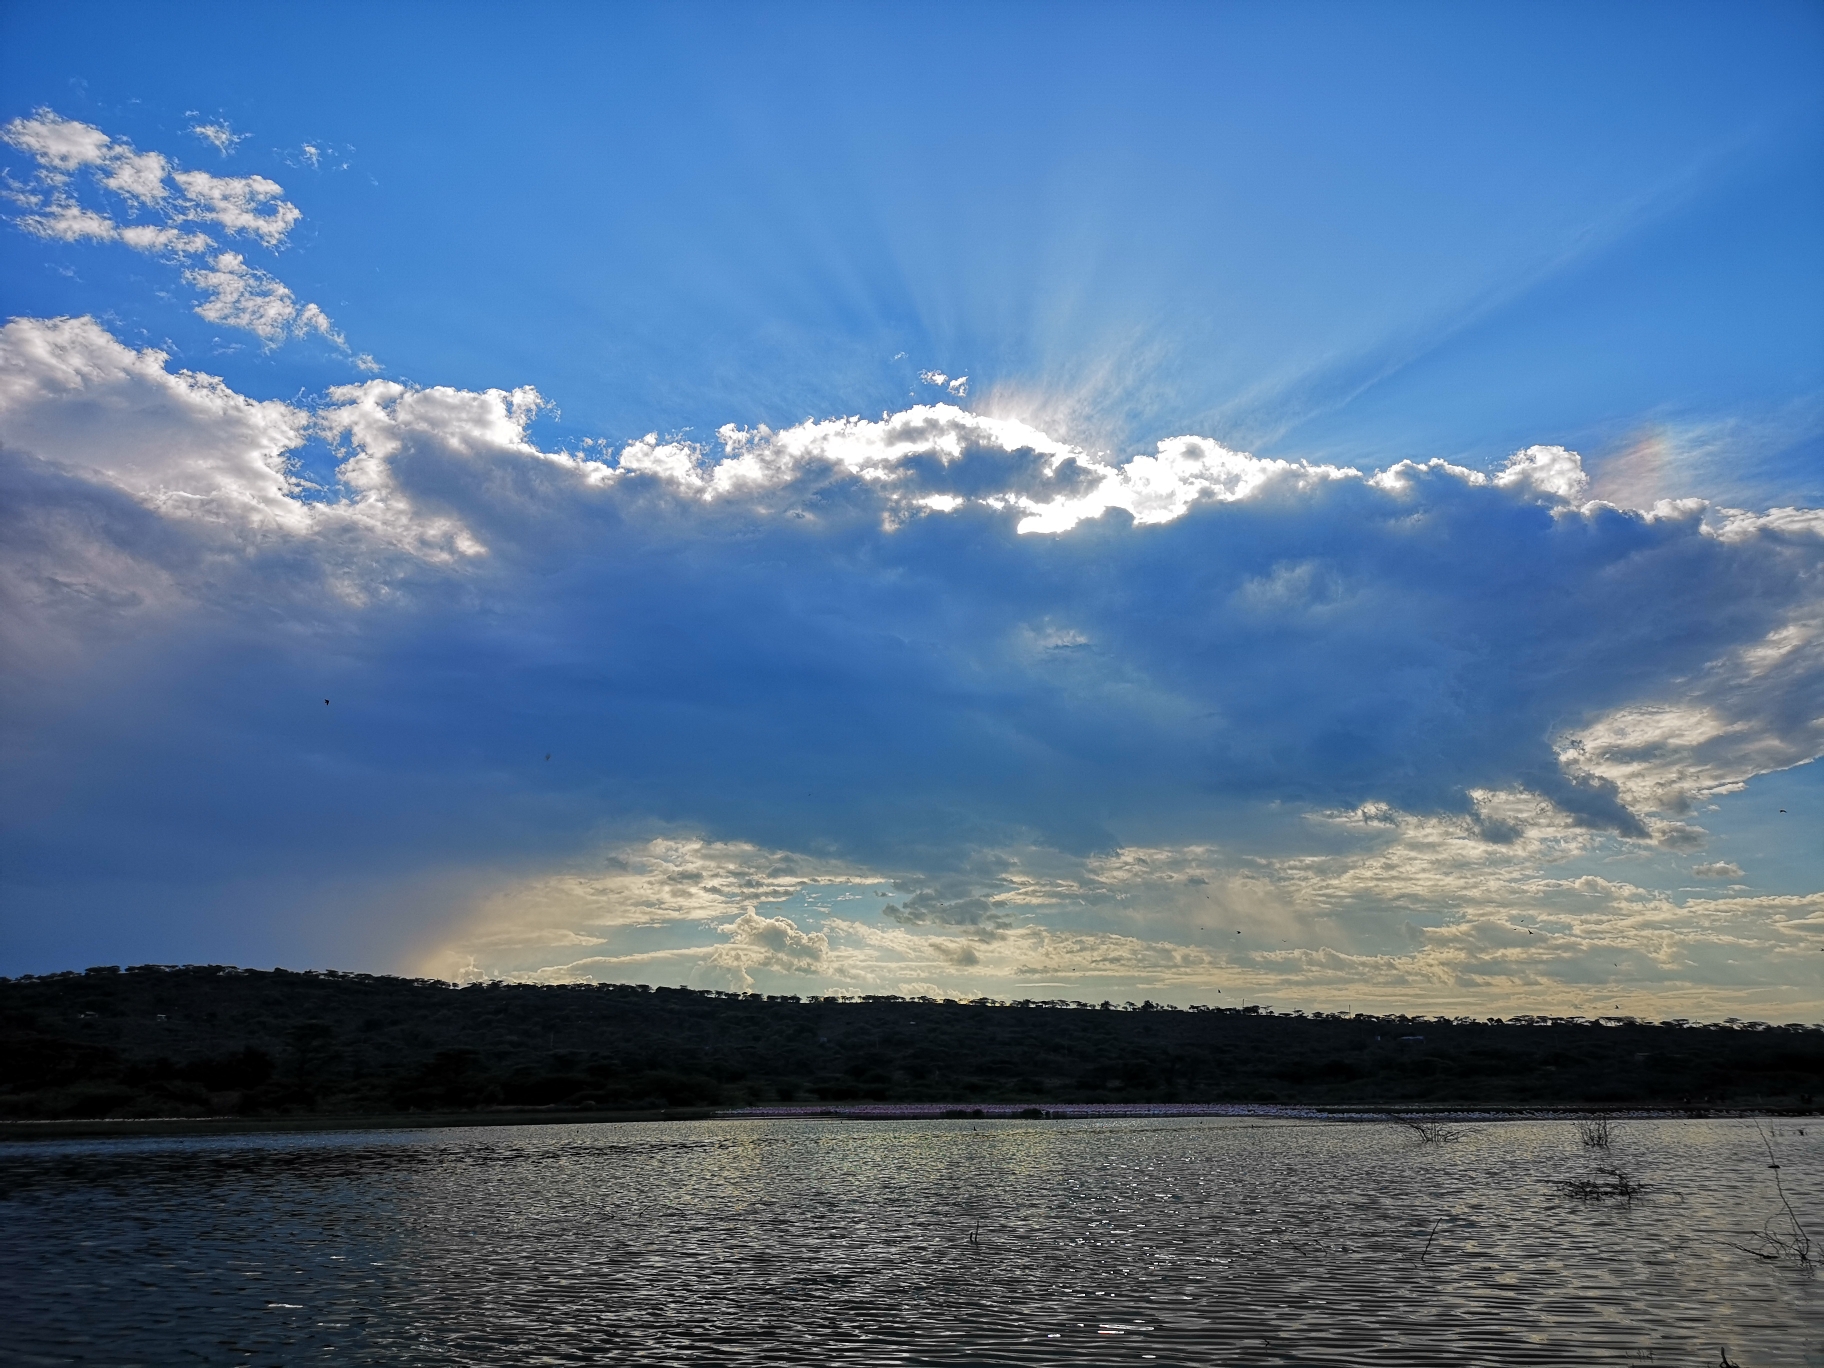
[{"x1": 0, "y1": 4, "x2": 1824, "y2": 1021}]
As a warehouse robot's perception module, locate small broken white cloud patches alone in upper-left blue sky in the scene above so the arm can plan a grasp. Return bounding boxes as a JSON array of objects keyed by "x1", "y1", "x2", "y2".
[{"x1": 0, "y1": 109, "x2": 339, "y2": 350}]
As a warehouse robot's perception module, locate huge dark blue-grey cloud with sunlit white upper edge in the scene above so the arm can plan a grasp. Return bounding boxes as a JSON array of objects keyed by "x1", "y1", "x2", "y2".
[{"x1": 0, "y1": 323, "x2": 1824, "y2": 963}]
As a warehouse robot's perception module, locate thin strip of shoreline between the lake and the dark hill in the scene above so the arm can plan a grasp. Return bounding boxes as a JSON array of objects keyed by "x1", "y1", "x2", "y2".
[{"x1": 0, "y1": 1102, "x2": 1819, "y2": 1144}]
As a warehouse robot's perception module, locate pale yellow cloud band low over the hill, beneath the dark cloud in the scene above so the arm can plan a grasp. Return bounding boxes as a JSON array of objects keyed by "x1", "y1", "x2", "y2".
[{"x1": 441, "y1": 819, "x2": 1824, "y2": 1016}]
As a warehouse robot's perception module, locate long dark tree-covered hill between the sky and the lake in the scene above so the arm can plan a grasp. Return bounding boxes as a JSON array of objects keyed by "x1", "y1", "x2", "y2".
[{"x1": 0, "y1": 965, "x2": 1824, "y2": 1120}]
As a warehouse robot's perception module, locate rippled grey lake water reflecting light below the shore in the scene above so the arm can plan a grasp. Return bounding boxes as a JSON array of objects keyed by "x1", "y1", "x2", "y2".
[{"x1": 0, "y1": 1118, "x2": 1824, "y2": 1368}]
